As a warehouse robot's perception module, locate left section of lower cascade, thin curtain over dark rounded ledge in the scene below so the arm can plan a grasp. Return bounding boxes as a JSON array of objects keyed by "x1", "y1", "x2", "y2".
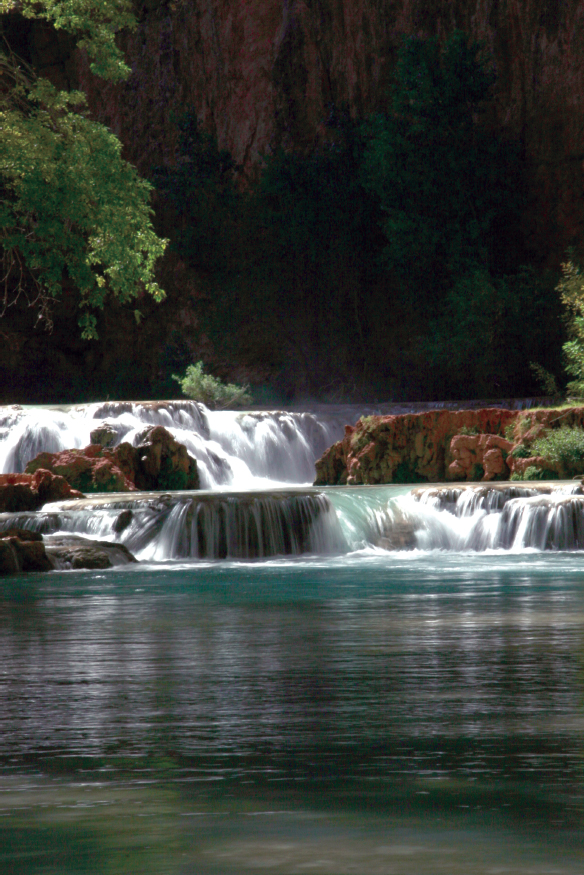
[{"x1": 0, "y1": 492, "x2": 347, "y2": 562}]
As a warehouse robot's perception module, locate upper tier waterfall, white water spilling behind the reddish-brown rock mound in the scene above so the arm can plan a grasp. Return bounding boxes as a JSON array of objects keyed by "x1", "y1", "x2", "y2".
[{"x1": 0, "y1": 401, "x2": 344, "y2": 489}]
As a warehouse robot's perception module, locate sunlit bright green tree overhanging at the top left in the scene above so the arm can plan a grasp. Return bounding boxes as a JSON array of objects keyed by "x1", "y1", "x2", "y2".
[{"x1": 0, "y1": 0, "x2": 166, "y2": 339}]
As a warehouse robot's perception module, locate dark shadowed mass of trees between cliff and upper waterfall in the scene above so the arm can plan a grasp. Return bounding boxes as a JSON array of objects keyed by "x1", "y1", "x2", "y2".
[{"x1": 0, "y1": 32, "x2": 563, "y2": 404}]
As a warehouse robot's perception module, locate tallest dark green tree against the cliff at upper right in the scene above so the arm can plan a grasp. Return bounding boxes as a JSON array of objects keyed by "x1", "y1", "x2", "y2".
[{"x1": 362, "y1": 32, "x2": 518, "y2": 300}]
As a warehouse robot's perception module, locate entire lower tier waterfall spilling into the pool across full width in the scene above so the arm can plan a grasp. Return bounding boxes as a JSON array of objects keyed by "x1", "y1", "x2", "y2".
[{"x1": 0, "y1": 484, "x2": 584, "y2": 562}]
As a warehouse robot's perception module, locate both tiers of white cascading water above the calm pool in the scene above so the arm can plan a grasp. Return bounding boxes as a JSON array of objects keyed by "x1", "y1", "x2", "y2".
[{"x1": 0, "y1": 401, "x2": 584, "y2": 562}]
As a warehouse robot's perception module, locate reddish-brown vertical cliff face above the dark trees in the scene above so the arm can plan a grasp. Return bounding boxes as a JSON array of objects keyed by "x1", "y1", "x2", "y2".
[{"x1": 65, "y1": 0, "x2": 584, "y2": 258}]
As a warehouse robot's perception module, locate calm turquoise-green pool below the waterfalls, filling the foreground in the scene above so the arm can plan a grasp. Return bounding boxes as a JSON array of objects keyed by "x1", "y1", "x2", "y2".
[{"x1": 0, "y1": 549, "x2": 584, "y2": 875}]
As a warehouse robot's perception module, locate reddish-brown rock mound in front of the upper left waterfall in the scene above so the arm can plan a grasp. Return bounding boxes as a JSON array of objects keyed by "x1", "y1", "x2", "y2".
[{"x1": 25, "y1": 426, "x2": 199, "y2": 496}]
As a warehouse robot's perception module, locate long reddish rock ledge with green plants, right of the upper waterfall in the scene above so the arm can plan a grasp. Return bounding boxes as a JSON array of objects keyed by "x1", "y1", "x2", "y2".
[{"x1": 315, "y1": 407, "x2": 584, "y2": 486}]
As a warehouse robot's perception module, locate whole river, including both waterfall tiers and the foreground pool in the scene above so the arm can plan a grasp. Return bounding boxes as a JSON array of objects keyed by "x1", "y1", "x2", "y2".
[{"x1": 0, "y1": 405, "x2": 584, "y2": 875}]
